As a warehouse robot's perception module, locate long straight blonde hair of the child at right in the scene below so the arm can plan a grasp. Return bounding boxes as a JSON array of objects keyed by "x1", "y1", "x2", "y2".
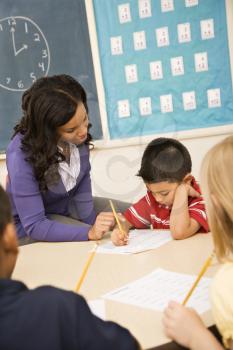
[{"x1": 201, "y1": 136, "x2": 233, "y2": 261}]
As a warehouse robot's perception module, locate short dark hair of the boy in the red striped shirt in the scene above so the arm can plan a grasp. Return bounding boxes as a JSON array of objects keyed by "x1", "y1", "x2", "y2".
[{"x1": 138, "y1": 137, "x2": 192, "y2": 183}]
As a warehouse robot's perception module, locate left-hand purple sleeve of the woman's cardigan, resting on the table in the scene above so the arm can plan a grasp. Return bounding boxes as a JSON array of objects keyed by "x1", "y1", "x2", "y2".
[{"x1": 7, "y1": 138, "x2": 93, "y2": 241}]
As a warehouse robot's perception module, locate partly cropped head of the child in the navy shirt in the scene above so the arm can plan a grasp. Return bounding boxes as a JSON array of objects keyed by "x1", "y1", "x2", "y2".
[{"x1": 0, "y1": 186, "x2": 18, "y2": 278}]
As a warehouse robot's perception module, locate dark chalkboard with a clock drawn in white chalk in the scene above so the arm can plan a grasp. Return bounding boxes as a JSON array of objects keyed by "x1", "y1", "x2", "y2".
[{"x1": 0, "y1": 0, "x2": 103, "y2": 153}]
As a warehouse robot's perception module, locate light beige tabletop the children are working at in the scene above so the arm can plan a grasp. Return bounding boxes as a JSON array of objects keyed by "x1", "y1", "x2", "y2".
[{"x1": 13, "y1": 233, "x2": 217, "y2": 348}]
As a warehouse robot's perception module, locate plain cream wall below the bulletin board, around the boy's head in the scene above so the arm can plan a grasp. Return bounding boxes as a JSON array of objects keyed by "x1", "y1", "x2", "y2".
[{"x1": 91, "y1": 135, "x2": 231, "y2": 202}]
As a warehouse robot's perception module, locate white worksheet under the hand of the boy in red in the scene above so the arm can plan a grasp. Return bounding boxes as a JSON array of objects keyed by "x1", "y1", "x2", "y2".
[{"x1": 97, "y1": 230, "x2": 172, "y2": 254}]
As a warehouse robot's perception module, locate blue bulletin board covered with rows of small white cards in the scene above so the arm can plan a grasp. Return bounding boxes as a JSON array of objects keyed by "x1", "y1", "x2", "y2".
[{"x1": 93, "y1": 0, "x2": 233, "y2": 139}]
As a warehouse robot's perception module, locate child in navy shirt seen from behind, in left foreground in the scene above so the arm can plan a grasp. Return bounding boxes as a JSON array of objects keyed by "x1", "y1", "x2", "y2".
[{"x1": 0, "y1": 187, "x2": 139, "y2": 350}]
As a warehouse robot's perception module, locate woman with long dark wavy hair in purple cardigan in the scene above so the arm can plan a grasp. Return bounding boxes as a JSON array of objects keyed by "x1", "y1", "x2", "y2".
[{"x1": 6, "y1": 75, "x2": 129, "y2": 244}]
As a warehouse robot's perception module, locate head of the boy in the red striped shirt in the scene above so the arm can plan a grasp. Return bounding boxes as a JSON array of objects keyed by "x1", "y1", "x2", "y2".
[{"x1": 138, "y1": 137, "x2": 192, "y2": 206}]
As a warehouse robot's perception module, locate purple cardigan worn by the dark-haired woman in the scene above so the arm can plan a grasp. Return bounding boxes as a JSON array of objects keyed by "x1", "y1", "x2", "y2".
[{"x1": 6, "y1": 134, "x2": 96, "y2": 242}]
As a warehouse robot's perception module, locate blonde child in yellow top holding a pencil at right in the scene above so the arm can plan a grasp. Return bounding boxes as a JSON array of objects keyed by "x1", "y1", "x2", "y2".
[{"x1": 163, "y1": 136, "x2": 233, "y2": 350}]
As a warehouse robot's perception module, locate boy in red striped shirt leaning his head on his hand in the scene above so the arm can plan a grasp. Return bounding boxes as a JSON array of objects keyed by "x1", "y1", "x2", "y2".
[{"x1": 111, "y1": 137, "x2": 208, "y2": 245}]
